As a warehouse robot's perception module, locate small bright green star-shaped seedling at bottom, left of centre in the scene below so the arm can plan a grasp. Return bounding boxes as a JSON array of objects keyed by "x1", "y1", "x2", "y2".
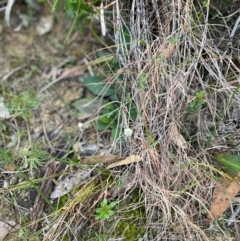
[{"x1": 96, "y1": 198, "x2": 117, "y2": 220}]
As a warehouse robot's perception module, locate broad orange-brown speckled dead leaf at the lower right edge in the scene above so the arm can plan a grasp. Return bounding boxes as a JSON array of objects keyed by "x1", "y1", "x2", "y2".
[{"x1": 210, "y1": 180, "x2": 240, "y2": 220}]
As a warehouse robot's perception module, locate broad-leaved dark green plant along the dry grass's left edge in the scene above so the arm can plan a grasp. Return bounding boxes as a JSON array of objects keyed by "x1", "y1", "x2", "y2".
[{"x1": 83, "y1": 56, "x2": 137, "y2": 140}]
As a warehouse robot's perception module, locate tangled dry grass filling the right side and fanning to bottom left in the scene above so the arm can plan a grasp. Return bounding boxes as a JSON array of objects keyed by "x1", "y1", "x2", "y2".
[{"x1": 1, "y1": 0, "x2": 240, "y2": 241}]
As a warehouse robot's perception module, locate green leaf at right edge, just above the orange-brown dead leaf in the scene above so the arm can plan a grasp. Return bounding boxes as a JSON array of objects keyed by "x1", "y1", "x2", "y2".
[{"x1": 214, "y1": 154, "x2": 240, "y2": 178}]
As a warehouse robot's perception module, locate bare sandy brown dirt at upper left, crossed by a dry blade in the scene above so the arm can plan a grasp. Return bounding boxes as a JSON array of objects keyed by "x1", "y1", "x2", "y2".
[{"x1": 0, "y1": 4, "x2": 103, "y2": 142}]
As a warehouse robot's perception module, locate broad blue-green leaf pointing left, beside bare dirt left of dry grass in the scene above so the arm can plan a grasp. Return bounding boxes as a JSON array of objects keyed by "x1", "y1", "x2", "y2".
[{"x1": 83, "y1": 76, "x2": 115, "y2": 97}]
